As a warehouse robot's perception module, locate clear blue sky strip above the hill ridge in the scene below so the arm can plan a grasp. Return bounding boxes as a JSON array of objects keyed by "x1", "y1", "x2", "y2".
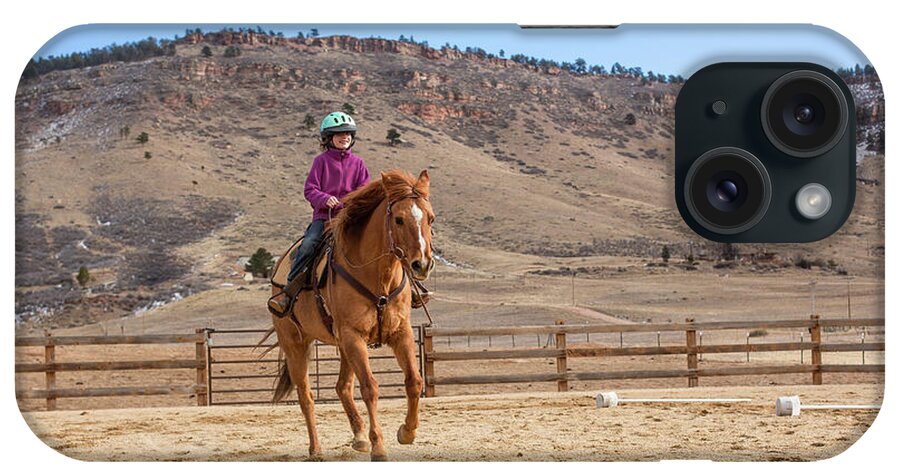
[{"x1": 34, "y1": 24, "x2": 868, "y2": 76}]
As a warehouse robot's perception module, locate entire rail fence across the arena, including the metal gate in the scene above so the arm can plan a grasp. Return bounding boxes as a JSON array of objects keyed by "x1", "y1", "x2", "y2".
[{"x1": 15, "y1": 315, "x2": 884, "y2": 410}]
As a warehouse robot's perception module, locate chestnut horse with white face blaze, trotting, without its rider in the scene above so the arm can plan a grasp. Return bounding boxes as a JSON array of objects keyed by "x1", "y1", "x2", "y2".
[{"x1": 272, "y1": 170, "x2": 434, "y2": 461}]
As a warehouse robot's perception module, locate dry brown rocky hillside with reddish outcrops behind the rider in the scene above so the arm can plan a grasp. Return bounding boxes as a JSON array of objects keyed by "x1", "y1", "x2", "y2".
[{"x1": 16, "y1": 32, "x2": 883, "y2": 328}]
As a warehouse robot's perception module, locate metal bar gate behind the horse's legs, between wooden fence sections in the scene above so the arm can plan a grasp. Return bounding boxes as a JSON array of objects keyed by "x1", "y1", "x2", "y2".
[{"x1": 206, "y1": 326, "x2": 425, "y2": 405}]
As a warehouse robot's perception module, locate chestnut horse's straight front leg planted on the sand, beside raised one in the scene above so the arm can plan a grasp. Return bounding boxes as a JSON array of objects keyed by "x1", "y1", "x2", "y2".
[{"x1": 339, "y1": 329, "x2": 387, "y2": 461}]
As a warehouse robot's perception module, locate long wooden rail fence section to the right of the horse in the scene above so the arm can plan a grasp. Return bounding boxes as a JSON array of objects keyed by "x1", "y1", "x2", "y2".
[{"x1": 423, "y1": 315, "x2": 884, "y2": 397}]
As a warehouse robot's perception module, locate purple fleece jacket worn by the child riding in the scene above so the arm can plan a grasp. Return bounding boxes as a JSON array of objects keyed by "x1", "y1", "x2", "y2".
[{"x1": 303, "y1": 149, "x2": 369, "y2": 220}]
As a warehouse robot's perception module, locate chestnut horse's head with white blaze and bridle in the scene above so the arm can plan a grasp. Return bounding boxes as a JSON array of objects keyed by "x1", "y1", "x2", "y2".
[{"x1": 381, "y1": 170, "x2": 434, "y2": 281}]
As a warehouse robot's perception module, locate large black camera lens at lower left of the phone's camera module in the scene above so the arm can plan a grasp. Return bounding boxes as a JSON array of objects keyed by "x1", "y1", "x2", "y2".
[{"x1": 684, "y1": 147, "x2": 772, "y2": 235}]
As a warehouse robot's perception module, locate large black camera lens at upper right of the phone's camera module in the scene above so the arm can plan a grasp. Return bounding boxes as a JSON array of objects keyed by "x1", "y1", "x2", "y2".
[{"x1": 761, "y1": 70, "x2": 849, "y2": 158}]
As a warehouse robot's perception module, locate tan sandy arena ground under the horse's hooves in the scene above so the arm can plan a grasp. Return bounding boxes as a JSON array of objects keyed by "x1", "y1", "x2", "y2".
[{"x1": 24, "y1": 384, "x2": 883, "y2": 461}]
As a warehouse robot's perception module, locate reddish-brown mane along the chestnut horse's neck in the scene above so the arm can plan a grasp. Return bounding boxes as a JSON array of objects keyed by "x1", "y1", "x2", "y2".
[{"x1": 328, "y1": 170, "x2": 428, "y2": 243}]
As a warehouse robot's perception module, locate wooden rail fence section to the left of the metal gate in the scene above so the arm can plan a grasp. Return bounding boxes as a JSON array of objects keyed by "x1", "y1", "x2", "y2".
[{"x1": 16, "y1": 329, "x2": 208, "y2": 410}]
